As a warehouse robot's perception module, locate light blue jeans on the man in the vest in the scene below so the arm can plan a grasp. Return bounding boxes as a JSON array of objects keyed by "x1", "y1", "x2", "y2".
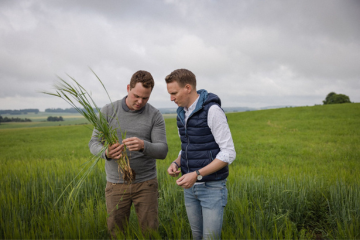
[{"x1": 184, "y1": 179, "x2": 227, "y2": 239}]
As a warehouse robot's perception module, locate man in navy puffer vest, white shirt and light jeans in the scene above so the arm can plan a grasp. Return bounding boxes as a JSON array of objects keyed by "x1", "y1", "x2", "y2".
[{"x1": 165, "y1": 69, "x2": 236, "y2": 239}]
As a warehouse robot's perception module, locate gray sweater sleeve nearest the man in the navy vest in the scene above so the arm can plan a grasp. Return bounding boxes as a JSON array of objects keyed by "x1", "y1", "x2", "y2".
[{"x1": 143, "y1": 111, "x2": 168, "y2": 159}]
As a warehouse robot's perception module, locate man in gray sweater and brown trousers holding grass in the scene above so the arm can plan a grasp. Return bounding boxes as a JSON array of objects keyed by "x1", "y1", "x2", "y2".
[{"x1": 89, "y1": 71, "x2": 168, "y2": 237}]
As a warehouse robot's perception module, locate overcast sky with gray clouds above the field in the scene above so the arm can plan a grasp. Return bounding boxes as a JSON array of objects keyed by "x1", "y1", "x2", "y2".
[{"x1": 0, "y1": 0, "x2": 360, "y2": 111}]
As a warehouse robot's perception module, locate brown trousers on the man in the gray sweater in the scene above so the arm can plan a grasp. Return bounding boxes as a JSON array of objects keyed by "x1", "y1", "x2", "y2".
[{"x1": 105, "y1": 178, "x2": 159, "y2": 237}]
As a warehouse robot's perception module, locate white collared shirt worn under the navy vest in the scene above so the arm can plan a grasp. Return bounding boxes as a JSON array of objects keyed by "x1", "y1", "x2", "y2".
[{"x1": 179, "y1": 97, "x2": 236, "y2": 164}]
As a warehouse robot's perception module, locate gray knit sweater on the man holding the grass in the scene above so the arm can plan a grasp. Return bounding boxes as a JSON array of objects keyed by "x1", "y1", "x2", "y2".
[{"x1": 89, "y1": 97, "x2": 168, "y2": 183}]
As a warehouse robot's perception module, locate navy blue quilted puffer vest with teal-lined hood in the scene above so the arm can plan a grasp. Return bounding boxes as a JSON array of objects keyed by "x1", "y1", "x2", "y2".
[{"x1": 177, "y1": 90, "x2": 229, "y2": 182}]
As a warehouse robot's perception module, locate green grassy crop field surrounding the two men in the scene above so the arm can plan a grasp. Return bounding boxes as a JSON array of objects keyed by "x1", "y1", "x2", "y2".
[{"x1": 0, "y1": 103, "x2": 360, "y2": 239}]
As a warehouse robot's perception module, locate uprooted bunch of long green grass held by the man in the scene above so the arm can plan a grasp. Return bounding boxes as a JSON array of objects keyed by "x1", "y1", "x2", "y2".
[{"x1": 43, "y1": 71, "x2": 135, "y2": 205}]
